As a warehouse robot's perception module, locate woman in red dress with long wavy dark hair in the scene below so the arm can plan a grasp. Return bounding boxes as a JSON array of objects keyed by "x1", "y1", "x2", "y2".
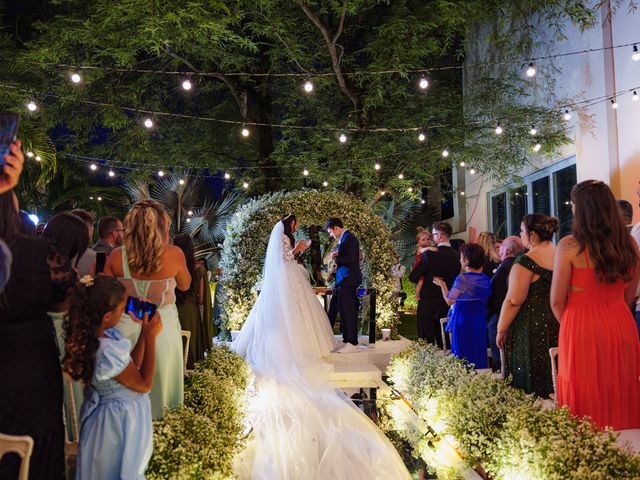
[{"x1": 551, "y1": 180, "x2": 640, "y2": 430}]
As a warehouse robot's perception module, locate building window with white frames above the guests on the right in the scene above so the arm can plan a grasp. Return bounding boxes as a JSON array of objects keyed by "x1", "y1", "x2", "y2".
[{"x1": 489, "y1": 157, "x2": 576, "y2": 238}]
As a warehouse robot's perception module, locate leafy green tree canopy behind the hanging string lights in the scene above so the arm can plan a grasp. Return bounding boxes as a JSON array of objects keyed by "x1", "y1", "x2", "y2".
[{"x1": 0, "y1": 0, "x2": 632, "y2": 210}]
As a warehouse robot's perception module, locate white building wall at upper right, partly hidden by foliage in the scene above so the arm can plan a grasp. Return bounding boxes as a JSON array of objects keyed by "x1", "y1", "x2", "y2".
[{"x1": 458, "y1": 2, "x2": 640, "y2": 237}]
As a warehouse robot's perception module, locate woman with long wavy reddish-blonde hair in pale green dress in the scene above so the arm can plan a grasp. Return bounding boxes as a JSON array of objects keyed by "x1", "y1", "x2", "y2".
[{"x1": 104, "y1": 200, "x2": 191, "y2": 418}]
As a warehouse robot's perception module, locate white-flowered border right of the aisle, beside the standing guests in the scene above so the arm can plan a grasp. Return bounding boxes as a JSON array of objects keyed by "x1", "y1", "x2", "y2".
[{"x1": 387, "y1": 341, "x2": 640, "y2": 480}]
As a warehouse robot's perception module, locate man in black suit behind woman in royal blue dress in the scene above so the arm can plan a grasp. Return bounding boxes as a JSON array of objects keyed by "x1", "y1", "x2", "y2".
[{"x1": 409, "y1": 222, "x2": 460, "y2": 348}]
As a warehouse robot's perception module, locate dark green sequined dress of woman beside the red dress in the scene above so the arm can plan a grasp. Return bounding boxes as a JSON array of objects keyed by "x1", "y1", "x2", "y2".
[{"x1": 505, "y1": 255, "x2": 560, "y2": 398}]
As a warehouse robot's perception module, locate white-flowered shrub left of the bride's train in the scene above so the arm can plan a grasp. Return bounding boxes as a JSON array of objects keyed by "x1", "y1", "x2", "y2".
[{"x1": 147, "y1": 346, "x2": 250, "y2": 480}]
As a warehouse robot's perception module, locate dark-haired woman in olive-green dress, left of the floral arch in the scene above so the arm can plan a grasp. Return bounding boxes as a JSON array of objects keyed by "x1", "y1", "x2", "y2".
[{"x1": 173, "y1": 233, "x2": 213, "y2": 369}]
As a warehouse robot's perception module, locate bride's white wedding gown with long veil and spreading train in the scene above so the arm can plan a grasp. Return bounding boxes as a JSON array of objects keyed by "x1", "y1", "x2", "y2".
[{"x1": 232, "y1": 222, "x2": 411, "y2": 480}]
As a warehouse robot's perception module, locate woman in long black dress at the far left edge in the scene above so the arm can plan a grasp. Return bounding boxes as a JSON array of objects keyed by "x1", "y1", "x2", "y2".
[{"x1": 0, "y1": 189, "x2": 76, "y2": 480}]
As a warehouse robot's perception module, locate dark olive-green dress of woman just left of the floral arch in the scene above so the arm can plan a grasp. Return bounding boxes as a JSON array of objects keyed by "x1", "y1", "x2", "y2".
[{"x1": 176, "y1": 266, "x2": 214, "y2": 369}]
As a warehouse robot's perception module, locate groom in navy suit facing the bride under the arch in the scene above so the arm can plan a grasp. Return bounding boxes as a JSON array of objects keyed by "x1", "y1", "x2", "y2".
[{"x1": 324, "y1": 217, "x2": 362, "y2": 353}]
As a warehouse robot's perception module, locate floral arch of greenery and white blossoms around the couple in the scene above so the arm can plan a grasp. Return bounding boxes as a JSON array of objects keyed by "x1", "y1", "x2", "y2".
[{"x1": 220, "y1": 190, "x2": 397, "y2": 331}]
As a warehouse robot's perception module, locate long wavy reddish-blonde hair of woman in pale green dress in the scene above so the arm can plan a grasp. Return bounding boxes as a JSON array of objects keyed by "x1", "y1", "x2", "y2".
[{"x1": 123, "y1": 200, "x2": 171, "y2": 275}]
